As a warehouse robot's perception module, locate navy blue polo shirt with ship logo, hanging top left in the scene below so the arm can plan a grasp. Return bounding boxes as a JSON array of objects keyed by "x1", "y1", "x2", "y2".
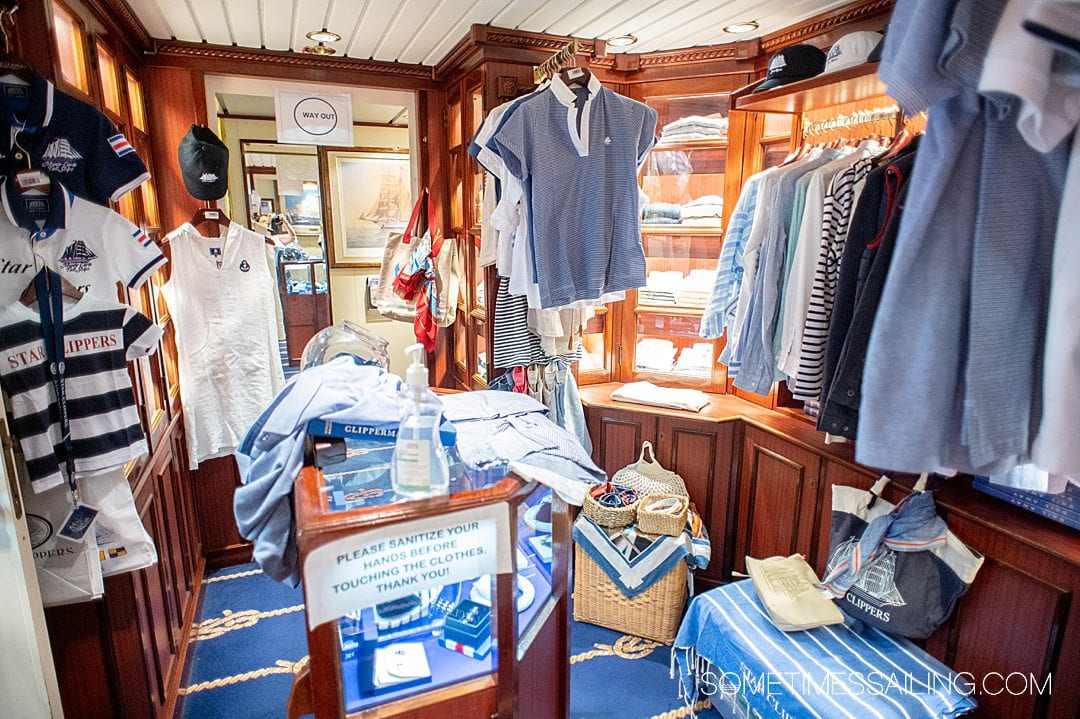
[{"x1": 0, "y1": 72, "x2": 150, "y2": 205}]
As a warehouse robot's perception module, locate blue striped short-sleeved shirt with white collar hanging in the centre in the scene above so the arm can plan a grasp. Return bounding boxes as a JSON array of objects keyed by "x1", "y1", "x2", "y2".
[{"x1": 491, "y1": 76, "x2": 657, "y2": 308}]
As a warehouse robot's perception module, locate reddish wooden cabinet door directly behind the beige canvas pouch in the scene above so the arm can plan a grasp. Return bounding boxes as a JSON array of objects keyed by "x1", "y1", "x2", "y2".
[{"x1": 732, "y1": 426, "x2": 821, "y2": 572}]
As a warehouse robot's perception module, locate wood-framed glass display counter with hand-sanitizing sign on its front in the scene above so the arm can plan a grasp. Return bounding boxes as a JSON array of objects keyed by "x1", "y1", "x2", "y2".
[{"x1": 289, "y1": 439, "x2": 570, "y2": 719}]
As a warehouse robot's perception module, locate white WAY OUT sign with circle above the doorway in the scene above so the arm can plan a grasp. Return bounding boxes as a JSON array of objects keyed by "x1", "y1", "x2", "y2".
[{"x1": 274, "y1": 90, "x2": 353, "y2": 147}]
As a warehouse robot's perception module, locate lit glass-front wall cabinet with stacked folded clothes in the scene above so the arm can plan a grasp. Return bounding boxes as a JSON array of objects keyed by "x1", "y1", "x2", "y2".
[{"x1": 619, "y1": 94, "x2": 729, "y2": 391}]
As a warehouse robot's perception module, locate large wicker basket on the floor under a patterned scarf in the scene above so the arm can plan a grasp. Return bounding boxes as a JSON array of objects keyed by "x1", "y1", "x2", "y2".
[{"x1": 573, "y1": 546, "x2": 687, "y2": 645}]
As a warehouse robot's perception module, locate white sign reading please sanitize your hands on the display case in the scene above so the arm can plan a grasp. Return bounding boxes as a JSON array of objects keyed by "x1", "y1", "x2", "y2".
[{"x1": 303, "y1": 503, "x2": 513, "y2": 628}]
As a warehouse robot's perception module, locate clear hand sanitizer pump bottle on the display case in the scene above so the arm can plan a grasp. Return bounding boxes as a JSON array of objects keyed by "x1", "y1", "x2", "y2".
[{"x1": 390, "y1": 344, "x2": 450, "y2": 499}]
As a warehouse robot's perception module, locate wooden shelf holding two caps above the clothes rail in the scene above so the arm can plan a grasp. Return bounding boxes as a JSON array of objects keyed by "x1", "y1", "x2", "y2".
[{"x1": 731, "y1": 63, "x2": 888, "y2": 114}]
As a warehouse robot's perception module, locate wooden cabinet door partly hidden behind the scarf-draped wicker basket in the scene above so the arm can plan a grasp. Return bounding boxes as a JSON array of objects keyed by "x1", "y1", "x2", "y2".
[{"x1": 657, "y1": 417, "x2": 735, "y2": 583}]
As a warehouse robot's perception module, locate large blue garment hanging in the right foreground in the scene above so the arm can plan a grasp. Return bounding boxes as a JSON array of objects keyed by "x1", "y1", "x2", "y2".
[{"x1": 856, "y1": 0, "x2": 1069, "y2": 474}]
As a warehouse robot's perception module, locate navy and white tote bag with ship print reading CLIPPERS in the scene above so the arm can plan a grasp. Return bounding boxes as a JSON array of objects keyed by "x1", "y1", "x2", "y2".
[{"x1": 822, "y1": 475, "x2": 983, "y2": 639}]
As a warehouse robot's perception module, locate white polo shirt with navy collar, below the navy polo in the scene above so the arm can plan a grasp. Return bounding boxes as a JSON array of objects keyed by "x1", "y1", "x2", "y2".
[{"x1": 0, "y1": 180, "x2": 165, "y2": 307}]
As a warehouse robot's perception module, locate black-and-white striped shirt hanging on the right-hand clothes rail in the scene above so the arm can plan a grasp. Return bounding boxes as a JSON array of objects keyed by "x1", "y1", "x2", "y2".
[{"x1": 793, "y1": 158, "x2": 874, "y2": 402}]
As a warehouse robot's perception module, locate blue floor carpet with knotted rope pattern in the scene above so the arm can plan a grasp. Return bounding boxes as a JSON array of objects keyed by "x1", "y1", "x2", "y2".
[{"x1": 177, "y1": 564, "x2": 715, "y2": 719}]
